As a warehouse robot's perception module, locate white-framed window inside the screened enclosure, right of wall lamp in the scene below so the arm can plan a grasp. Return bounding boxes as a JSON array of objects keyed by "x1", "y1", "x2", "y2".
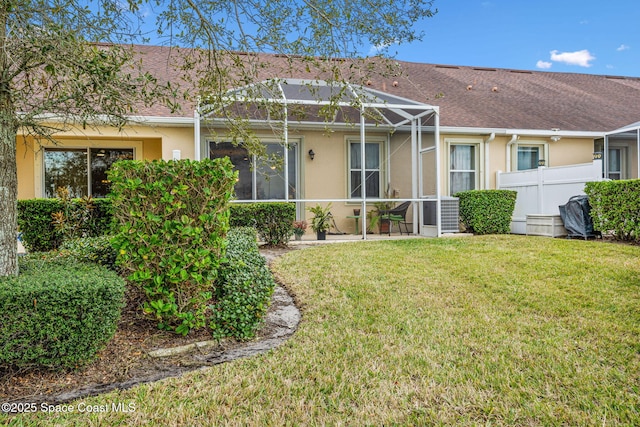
[{"x1": 349, "y1": 141, "x2": 382, "y2": 198}]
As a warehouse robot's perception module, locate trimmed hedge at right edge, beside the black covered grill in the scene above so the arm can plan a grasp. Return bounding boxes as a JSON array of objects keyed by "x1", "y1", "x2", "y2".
[{"x1": 584, "y1": 179, "x2": 640, "y2": 242}]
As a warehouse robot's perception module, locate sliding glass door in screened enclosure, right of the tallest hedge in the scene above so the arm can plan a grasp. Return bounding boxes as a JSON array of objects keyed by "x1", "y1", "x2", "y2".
[{"x1": 209, "y1": 141, "x2": 298, "y2": 200}]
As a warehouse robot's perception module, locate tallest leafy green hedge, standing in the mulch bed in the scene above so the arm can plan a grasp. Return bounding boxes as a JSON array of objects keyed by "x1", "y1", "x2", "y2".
[{"x1": 108, "y1": 158, "x2": 237, "y2": 334}]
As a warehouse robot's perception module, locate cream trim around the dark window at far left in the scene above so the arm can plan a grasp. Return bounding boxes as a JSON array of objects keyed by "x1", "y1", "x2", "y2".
[{"x1": 33, "y1": 139, "x2": 143, "y2": 198}]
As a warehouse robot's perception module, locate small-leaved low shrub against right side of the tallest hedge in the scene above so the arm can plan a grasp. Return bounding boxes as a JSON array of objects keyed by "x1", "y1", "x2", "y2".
[{"x1": 210, "y1": 227, "x2": 275, "y2": 340}]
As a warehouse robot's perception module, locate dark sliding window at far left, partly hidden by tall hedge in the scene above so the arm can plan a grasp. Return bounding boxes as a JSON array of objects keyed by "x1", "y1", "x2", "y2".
[{"x1": 44, "y1": 148, "x2": 133, "y2": 198}]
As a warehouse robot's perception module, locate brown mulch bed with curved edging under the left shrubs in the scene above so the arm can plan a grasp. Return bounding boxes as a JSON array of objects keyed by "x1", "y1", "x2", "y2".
[{"x1": 0, "y1": 246, "x2": 298, "y2": 404}]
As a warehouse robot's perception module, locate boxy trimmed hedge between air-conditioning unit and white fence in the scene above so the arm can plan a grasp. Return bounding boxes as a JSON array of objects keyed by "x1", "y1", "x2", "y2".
[{"x1": 454, "y1": 190, "x2": 518, "y2": 234}]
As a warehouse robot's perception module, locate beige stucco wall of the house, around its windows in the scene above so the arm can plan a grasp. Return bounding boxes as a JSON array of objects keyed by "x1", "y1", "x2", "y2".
[{"x1": 17, "y1": 118, "x2": 604, "y2": 233}]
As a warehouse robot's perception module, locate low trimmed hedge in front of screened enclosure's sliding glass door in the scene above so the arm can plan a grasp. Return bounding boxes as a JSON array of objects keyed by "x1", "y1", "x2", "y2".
[{"x1": 230, "y1": 202, "x2": 296, "y2": 246}]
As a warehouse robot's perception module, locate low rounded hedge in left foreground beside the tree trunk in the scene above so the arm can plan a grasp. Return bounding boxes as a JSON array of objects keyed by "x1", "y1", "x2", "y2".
[{"x1": 0, "y1": 257, "x2": 125, "y2": 369}]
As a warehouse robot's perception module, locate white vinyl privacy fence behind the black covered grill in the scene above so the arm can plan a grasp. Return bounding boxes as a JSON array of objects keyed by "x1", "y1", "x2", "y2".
[{"x1": 496, "y1": 160, "x2": 602, "y2": 234}]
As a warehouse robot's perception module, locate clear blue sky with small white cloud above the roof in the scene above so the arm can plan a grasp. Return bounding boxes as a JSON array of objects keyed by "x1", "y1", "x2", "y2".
[{"x1": 380, "y1": 0, "x2": 640, "y2": 77}]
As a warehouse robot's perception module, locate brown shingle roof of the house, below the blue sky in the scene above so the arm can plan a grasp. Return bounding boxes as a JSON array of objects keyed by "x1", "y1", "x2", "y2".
[{"x1": 132, "y1": 46, "x2": 640, "y2": 132}]
